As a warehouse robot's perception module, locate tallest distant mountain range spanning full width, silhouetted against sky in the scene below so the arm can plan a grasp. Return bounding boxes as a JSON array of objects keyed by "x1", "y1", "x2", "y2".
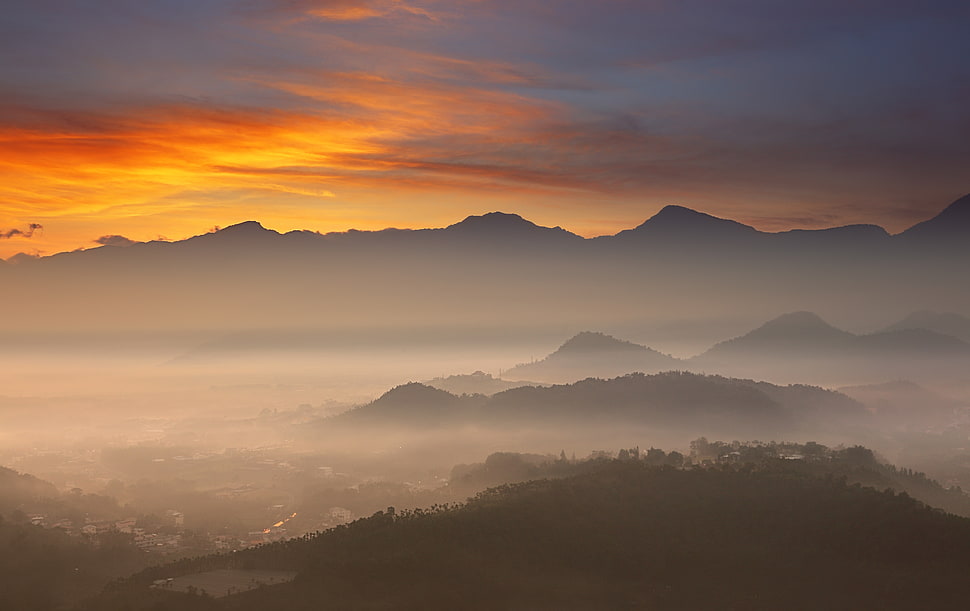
[{"x1": 0, "y1": 196, "x2": 970, "y2": 340}]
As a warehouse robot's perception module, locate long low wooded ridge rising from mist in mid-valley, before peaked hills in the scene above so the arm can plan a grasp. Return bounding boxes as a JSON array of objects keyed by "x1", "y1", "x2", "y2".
[{"x1": 324, "y1": 372, "x2": 869, "y2": 436}]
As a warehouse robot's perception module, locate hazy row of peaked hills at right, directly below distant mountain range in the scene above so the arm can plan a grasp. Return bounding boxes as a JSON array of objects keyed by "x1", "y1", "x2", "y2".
[{"x1": 483, "y1": 311, "x2": 970, "y2": 394}]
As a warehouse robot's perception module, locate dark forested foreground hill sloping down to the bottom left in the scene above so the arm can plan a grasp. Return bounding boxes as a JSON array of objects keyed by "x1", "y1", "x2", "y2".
[{"x1": 85, "y1": 460, "x2": 970, "y2": 611}]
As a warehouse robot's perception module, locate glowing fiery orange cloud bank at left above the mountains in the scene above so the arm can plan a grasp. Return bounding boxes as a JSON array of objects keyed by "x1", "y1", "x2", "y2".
[{"x1": 0, "y1": 61, "x2": 588, "y2": 257}]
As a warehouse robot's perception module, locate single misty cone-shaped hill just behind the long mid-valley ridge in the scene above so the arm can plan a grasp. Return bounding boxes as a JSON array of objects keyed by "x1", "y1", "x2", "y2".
[{"x1": 503, "y1": 331, "x2": 680, "y2": 382}]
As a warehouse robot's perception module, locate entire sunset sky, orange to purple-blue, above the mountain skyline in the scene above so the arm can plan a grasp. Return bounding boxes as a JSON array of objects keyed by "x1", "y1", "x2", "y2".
[{"x1": 0, "y1": 0, "x2": 970, "y2": 258}]
